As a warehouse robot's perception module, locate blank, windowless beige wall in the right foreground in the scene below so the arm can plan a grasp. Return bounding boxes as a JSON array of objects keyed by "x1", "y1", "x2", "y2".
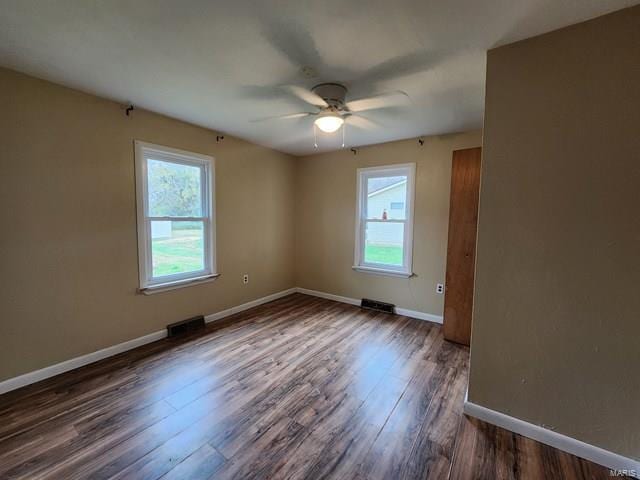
[{"x1": 469, "y1": 7, "x2": 640, "y2": 458}]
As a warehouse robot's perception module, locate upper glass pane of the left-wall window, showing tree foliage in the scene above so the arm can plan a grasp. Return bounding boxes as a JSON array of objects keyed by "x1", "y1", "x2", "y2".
[{"x1": 147, "y1": 159, "x2": 202, "y2": 217}]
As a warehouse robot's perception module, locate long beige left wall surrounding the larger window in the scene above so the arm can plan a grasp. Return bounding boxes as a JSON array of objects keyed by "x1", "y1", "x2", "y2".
[{"x1": 0, "y1": 70, "x2": 295, "y2": 380}]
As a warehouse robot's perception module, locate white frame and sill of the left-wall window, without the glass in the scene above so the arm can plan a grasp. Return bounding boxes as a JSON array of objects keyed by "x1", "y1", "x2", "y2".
[{"x1": 135, "y1": 140, "x2": 218, "y2": 294}]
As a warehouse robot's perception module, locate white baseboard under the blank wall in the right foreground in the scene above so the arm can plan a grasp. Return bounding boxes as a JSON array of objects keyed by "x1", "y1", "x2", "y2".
[{"x1": 464, "y1": 400, "x2": 640, "y2": 478}]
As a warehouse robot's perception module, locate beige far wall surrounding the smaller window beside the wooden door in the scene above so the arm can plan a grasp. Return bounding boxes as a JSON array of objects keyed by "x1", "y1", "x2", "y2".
[{"x1": 296, "y1": 131, "x2": 481, "y2": 315}]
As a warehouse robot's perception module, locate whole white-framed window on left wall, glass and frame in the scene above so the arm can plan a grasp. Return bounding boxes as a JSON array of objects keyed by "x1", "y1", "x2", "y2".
[{"x1": 136, "y1": 142, "x2": 217, "y2": 292}]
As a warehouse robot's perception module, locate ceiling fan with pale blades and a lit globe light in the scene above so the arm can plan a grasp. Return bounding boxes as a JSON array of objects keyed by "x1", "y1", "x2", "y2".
[{"x1": 254, "y1": 83, "x2": 409, "y2": 137}]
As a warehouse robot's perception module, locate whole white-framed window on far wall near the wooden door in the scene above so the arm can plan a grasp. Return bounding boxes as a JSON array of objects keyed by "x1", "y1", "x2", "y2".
[{"x1": 353, "y1": 163, "x2": 415, "y2": 277}]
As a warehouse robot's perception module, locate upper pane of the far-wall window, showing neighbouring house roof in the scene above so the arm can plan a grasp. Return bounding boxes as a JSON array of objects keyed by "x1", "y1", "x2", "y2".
[{"x1": 367, "y1": 175, "x2": 407, "y2": 220}]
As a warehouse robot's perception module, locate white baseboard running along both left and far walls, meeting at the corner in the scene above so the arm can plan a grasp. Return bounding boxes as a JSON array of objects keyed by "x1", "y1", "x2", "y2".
[{"x1": 0, "y1": 287, "x2": 442, "y2": 395}]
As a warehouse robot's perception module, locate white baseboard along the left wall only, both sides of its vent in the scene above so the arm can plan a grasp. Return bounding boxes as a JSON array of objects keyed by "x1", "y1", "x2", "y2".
[{"x1": 0, "y1": 288, "x2": 296, "y2": 395}]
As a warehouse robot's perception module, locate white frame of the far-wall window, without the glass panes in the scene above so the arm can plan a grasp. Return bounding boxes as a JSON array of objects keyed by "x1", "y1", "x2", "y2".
[{"x1": 353, "y1": 163, "x2": 416, "y2": 278}]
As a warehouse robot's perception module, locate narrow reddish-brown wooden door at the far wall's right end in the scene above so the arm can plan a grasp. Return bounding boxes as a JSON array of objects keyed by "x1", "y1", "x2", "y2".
[{"x1": 443, "y1": 147, "x2": 482, "y2": 345}]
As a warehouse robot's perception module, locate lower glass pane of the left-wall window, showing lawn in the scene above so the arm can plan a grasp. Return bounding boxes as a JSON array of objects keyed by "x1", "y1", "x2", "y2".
[{"x1": 151, "y1": 221, "x2": 204, "y2": 278}]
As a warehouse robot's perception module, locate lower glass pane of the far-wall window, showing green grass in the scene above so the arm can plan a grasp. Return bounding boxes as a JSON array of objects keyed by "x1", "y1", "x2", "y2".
[{"x1": 364, "y1": 222, "x2": 404, "y2": 267}]
